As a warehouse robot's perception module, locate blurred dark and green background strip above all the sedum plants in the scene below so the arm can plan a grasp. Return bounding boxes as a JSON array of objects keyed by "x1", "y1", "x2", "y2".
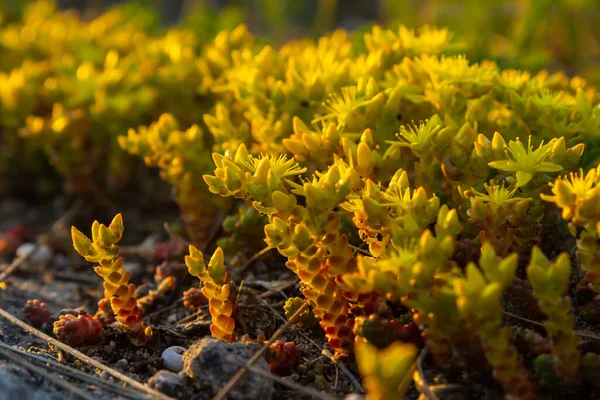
[{"x1": 0, "y1": 0, "x2": 600, "y2": 84}]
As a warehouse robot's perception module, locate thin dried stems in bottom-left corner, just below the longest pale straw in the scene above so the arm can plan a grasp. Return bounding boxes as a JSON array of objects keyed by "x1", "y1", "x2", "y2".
[{"x1": 0, "y1": 341, "x2": 148, "y2": 400}]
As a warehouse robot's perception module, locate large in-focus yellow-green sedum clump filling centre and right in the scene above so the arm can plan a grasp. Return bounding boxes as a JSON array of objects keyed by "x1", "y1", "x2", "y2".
[{"x1": 189, "y1": 20, "x2": 600, "y2": 399}]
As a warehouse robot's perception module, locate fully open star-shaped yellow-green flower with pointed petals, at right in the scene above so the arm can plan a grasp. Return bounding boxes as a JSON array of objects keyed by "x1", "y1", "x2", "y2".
[{"x1": 488, "y1": 136, "x2": 563, "y2": 186}]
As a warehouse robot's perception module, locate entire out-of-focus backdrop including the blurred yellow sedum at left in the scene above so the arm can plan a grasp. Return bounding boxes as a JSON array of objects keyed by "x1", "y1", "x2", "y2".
[{"x1": 0, "y1": 0, "x2": 600, "y2": 222}]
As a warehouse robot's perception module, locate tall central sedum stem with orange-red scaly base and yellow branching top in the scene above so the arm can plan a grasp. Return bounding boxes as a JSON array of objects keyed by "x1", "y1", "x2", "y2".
[{"x1": 204, "y1": 145, "x2": 355, "y2": 351}]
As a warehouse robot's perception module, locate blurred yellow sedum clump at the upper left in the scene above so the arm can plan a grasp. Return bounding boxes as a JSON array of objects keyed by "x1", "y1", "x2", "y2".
[{"x1": 0, "y1": 0, "x2": 244, "y2": 195}]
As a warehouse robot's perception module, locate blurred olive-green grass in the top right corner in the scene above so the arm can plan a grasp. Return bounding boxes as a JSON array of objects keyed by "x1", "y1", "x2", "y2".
[{"x1": 381, "y1": 0, "x2": 600, "y2": 84}]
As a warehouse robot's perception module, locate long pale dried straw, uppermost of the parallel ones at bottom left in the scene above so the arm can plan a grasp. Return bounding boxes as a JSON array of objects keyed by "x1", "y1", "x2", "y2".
[{"x1": 0, "y1": 308, "x2": 173, "y2": 400}]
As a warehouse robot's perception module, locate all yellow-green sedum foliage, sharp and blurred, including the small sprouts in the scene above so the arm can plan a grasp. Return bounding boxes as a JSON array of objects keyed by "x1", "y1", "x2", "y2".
[{"x1": 0, "y1": 2, "x2": 600, "y2": 399}]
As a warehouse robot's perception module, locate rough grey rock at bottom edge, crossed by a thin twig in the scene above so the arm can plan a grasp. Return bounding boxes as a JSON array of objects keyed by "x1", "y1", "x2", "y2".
[{"x1": 183, "y1": 337, "x2": 273, "y2": 400}]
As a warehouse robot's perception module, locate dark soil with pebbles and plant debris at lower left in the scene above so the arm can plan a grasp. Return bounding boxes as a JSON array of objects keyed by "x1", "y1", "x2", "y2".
[{"x1": 0, "y1": 200, "x2": 358, "y2": 399}]
